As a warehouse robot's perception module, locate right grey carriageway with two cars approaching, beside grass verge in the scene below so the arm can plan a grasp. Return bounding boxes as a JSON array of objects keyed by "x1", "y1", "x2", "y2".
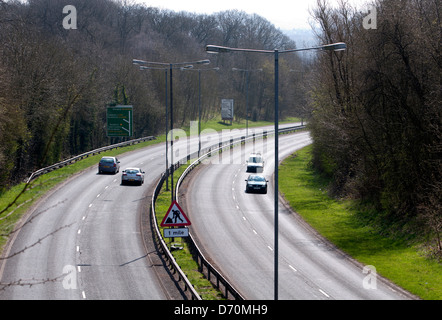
[{"x1": 185, "y1": 132, "x2": 407, "y2": 300}]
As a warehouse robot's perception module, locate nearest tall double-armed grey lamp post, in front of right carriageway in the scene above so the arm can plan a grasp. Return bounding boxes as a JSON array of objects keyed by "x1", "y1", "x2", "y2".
[{"x1": 206, "y1": 42, "x2": 347, "y2": 300}]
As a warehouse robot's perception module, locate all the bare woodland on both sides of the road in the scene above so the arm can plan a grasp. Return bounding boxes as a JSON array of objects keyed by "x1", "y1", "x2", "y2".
[{"x1": 0, "y1": 0, "x2": 442, "y2": 258}]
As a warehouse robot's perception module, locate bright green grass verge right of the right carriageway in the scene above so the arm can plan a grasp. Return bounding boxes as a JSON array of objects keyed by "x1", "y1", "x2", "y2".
[{"x1": 279, "y1": 146, "x2": 442, "y2": 300}]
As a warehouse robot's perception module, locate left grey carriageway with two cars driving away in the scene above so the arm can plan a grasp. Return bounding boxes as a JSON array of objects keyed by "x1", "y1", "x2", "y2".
[{"x1": 0, "y1": 123, "x2": 298, "y2": 300}]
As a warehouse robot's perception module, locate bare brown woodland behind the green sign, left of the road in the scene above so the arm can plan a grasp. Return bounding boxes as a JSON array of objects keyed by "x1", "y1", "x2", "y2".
[{"x1": 0, "y1": 0, "x2": 304, "y2": 190}]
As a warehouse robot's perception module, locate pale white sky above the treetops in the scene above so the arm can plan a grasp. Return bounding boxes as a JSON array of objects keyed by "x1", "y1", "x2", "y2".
[{"x1": 135, "y1": 0, "x2": 370, "y2": 30}]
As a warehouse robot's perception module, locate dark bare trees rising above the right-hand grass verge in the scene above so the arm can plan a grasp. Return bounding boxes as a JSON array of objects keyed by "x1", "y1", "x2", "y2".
[{"x1": 310, "y1": 0, "x2": 442, "y2": 257}]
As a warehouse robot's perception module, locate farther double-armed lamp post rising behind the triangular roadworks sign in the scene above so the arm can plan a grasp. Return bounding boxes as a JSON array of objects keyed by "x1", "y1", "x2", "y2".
[{"x1": 132, "y1": 59, "x2": 210, "y2": 202}]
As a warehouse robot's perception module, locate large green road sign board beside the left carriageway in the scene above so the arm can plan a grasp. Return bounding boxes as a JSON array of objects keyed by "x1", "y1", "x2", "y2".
[{"x1": 106, "y1": 106, "x2": 133, "y2": 137}]
